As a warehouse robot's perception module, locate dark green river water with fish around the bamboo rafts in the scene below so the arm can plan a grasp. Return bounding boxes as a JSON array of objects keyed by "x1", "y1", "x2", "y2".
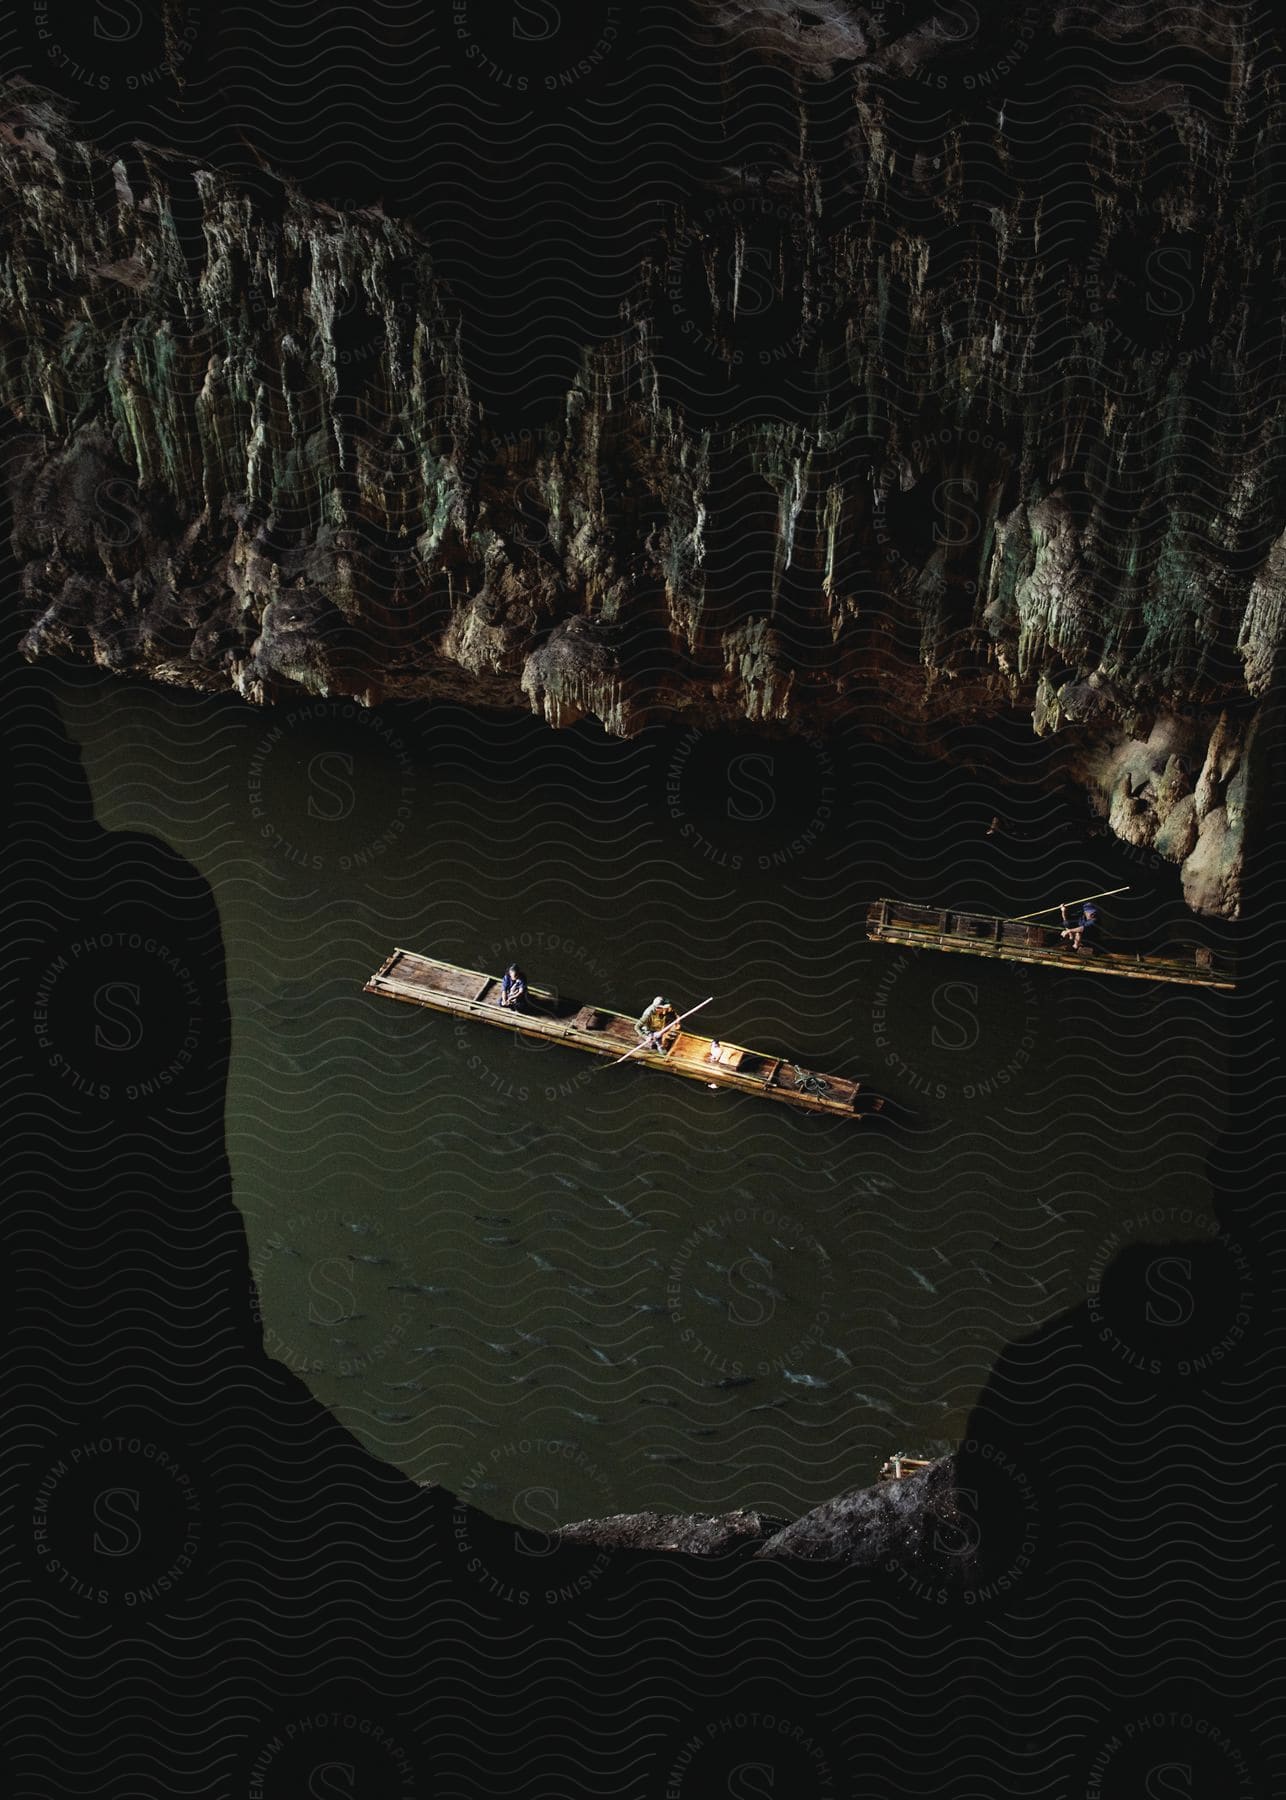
[{"x1": 59, "y1": 673, "x2": 1223, "y2": 1526}]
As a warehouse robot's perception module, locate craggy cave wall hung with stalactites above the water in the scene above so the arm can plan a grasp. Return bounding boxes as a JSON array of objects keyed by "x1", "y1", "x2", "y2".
[{"x1": 0, "y1": 0, "x2": 1286, "y2": 913}]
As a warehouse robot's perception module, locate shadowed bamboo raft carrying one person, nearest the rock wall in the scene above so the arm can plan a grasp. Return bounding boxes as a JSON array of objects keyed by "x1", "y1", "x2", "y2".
[{"x1": 866, "y1": 900, "x2": 1236, "y2": 988}]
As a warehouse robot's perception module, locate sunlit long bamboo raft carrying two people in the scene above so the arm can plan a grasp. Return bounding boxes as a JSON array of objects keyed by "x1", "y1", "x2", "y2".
[{"x1": 364, "y1": 950, "x2": 884, "y2": 1118}]
